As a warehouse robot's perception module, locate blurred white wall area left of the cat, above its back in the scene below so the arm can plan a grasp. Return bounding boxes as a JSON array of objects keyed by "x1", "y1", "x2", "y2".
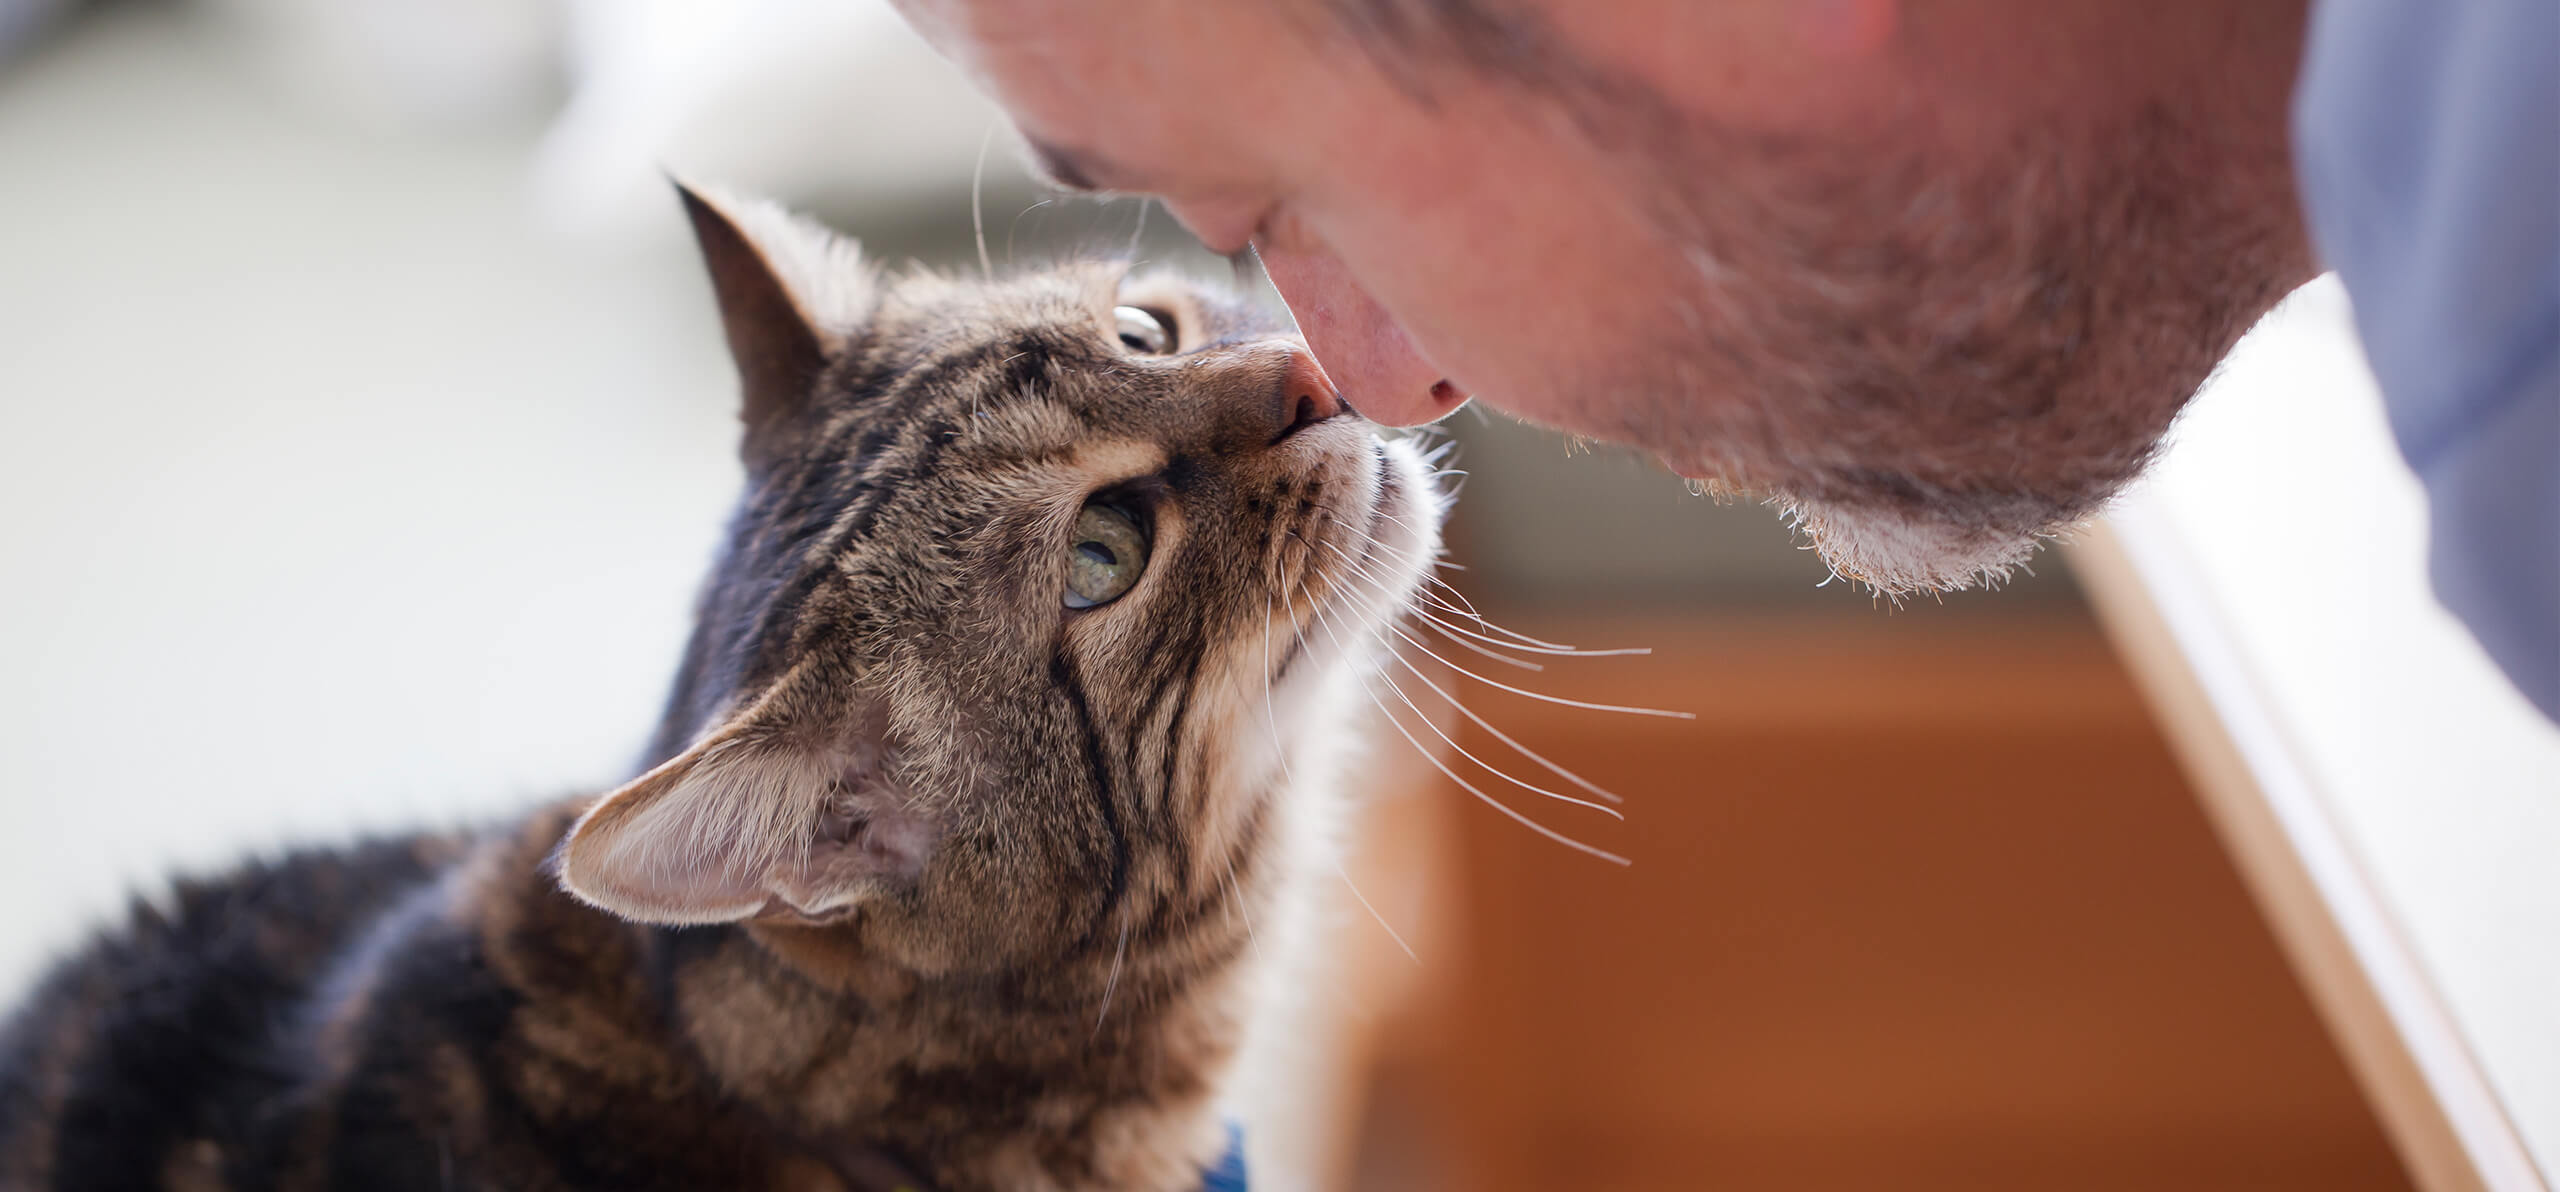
[{"x1": 0, "y1": 10, "x2": 735, "y2": 987}]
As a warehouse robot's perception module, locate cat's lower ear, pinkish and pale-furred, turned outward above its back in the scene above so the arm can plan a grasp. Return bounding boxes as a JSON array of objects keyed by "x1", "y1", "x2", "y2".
[{"x1": 556, "y1": 670, "x2": 940, "y2": 926}]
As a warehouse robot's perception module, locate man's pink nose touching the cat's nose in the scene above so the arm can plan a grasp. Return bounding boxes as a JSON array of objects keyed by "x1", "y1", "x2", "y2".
[{"x1": 1262, "y1": 251, "x2": 1467, "y2": 427}]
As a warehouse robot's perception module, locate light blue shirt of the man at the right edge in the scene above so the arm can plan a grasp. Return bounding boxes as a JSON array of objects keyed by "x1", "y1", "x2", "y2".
[{"x1": 2294, "y1": 0, "x2": 2560, "y2": 721}]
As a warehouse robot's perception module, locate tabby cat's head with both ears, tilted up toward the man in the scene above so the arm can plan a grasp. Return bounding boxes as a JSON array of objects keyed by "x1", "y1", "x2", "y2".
[{"x1": 558, "y1": 192, "x2": 1441, "y2": 972}]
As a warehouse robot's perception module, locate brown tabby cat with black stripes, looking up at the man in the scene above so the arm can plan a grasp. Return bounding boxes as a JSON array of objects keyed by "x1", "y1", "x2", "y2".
[{"x1": 0, "y1": 181, "x2": 1441, "y2": 1192}]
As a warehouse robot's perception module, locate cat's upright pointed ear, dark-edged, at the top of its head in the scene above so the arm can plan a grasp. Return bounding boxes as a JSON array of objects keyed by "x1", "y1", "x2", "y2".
[{"x1": 676, "y1": 182, "x2": 878, "y2": 458}]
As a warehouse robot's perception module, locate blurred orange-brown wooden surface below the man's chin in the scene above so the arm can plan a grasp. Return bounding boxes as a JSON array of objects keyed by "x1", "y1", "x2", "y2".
[{"x1": 1367, "y1": 614, "x2": 2409, "y2": 1192}]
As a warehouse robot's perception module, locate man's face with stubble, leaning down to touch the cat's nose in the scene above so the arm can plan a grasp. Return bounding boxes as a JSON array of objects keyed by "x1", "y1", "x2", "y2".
[{"x1": 901, "y1": 0, "x2": 2301, "y2": 593}]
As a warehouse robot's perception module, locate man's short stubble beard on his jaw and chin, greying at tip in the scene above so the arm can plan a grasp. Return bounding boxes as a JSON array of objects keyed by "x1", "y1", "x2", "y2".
[{"x1": 1585, "y1": 110, "x2": 2286, "y2": 596}]
